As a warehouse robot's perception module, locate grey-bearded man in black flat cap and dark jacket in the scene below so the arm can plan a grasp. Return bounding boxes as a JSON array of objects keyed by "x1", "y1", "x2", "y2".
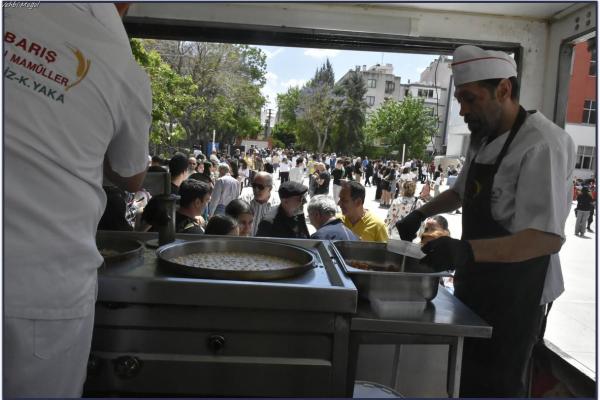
[{"x1": 256, "y1": 181, "x2": 309, "y2": 239}]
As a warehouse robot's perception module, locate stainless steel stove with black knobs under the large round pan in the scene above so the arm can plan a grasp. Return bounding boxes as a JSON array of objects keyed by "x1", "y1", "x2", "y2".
[{"x1": 84, "y1": 232, "x2": 357, "y2": 397}]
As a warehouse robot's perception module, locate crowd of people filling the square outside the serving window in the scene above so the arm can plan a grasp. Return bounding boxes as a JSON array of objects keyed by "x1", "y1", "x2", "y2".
[{"x1": 100, "y1": 148, "x2": 457, "y2": 242}]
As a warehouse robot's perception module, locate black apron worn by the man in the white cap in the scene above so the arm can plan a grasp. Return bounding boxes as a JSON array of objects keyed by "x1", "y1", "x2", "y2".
[{"x1": 454, "y1": 107, "x2": 550, "y2": 397}]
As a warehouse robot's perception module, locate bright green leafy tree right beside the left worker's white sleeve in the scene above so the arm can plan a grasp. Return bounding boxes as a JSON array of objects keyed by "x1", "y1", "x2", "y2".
[{"x1": 130, "y1": 39, "x2": 197, "y2": 149}]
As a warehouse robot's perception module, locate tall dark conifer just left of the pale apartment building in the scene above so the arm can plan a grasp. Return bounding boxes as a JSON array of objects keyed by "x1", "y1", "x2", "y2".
[{"x1": 334, "y1": 71, "x2": 367, "y2": 153}]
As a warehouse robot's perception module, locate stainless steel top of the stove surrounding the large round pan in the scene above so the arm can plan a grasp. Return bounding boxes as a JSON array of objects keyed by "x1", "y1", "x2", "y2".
[{"x1": 98, "y1": 232, "x2": 357, "y2": 314}]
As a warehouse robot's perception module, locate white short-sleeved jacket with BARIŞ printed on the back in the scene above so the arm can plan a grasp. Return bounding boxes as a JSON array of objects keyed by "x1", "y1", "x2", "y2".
[{"x1": 3, "y1": 3, "x2": 152, "y2": 319}]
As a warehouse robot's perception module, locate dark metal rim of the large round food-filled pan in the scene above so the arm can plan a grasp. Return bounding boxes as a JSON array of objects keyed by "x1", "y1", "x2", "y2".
[{"x1": 156, "y1": 238, "x2": 316, "y2": 281}]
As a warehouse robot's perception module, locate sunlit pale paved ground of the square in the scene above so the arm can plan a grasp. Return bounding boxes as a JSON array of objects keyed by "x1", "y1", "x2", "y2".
[{"x1": 268, "y1": 174, "x2": 597, "y2": 378}]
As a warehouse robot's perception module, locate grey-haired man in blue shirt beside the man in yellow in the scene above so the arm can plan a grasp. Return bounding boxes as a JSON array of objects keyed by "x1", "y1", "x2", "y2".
[{"x1": 308, "y1": 194, "x2": 359, "y2": 240}]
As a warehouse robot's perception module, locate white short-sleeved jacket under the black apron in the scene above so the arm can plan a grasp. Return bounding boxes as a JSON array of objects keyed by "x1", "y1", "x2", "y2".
[{"x1": 451, "y1": 111, "x2": 575, "y2": 304}]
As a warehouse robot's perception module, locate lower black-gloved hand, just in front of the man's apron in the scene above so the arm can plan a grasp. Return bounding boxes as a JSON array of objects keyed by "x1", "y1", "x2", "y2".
[{"x1": 421, "y1": 236, "x2": 474, "y2": 272}]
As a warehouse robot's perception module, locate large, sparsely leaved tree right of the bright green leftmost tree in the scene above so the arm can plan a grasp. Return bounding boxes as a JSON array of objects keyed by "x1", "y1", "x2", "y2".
[{"x1": 142, "y1": 41, "x2": 266, "y2": 148}]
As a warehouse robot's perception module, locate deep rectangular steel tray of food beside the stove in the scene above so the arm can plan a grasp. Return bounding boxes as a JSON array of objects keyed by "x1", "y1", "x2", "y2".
[{"x1": 331, "y1": 241, "x2": 450, "y2": 301}]
